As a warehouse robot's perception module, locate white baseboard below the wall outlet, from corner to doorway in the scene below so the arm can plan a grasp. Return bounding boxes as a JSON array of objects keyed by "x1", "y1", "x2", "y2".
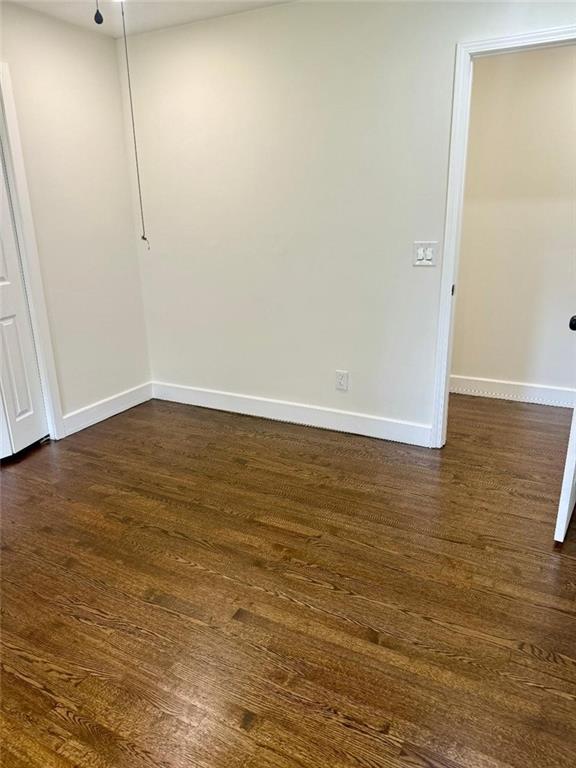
[{"x1": 152, "y1": 381, "x2": 431, "y2": 448}]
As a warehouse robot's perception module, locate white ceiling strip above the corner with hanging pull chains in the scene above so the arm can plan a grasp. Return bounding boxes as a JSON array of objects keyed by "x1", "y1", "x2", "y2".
[{"x1": 13, "y1": 0, "x2": 289, "y2": 37}]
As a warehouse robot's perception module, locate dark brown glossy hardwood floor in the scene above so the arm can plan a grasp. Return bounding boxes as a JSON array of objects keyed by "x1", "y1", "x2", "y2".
[{"x1": 1, "y1": 396, "x2": 576, "y2": 768}]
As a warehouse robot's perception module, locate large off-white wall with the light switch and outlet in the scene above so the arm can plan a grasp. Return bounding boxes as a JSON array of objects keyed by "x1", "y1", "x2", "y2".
[{"x1": 125, "y1": 2, "x2": 576, "y2": 438}]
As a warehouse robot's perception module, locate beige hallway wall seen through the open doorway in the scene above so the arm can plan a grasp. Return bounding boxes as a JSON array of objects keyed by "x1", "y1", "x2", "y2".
[{"x1": 452, "y1": 46, "x2": 576, "y2": 404}]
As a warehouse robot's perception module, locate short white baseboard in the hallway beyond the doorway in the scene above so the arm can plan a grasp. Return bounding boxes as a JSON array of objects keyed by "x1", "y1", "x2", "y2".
[{"x1": 450, "y1": 376, "x2": 576, "y2": 408}]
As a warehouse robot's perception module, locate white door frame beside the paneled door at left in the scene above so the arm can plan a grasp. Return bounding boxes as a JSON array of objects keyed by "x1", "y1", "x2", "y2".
[{"x1": 0, "y1": 62, "x2": 66, "y2": 440}]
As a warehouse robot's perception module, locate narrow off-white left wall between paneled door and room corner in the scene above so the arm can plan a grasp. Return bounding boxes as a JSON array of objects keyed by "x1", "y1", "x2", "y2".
[{"x1": 0, "y1": 3, "x2": 150, "y2": 413}]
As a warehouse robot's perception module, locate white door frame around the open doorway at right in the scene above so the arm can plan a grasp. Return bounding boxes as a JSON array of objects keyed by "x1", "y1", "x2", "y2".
[{"x1": 430, "y1": 26, "x2": 576, "y2": 448}]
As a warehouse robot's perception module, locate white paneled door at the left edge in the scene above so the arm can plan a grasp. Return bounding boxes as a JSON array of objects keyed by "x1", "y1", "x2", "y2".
[{"x1": 0, "y1": 137, "x2": 48, "y2": 453}]
